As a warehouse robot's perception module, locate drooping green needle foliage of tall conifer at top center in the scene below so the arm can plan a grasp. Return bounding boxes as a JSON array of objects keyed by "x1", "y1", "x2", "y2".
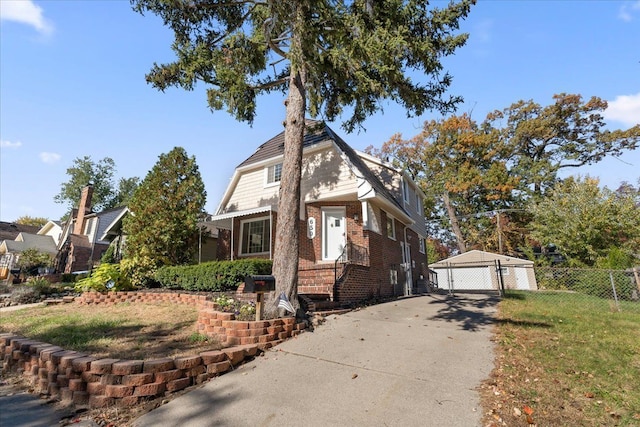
[{"x1": 132, "y1": 0, "x2": 474, "y2": 131}]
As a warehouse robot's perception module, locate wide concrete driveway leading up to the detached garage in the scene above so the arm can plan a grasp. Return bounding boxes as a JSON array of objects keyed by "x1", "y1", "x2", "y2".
[{"x1": 134, "y1": 294, "x2": 497, "y2": 427}]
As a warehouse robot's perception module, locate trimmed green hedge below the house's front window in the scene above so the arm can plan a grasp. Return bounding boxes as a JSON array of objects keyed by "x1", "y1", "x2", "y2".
[{"x1": 156, "y1": 258, "x2": 273, "y2": 292}]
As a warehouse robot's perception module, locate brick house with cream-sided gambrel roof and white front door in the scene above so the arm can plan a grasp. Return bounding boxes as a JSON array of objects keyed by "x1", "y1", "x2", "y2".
[{"x1": 210, "y1": 121, "x2": 427, "y2": 302}]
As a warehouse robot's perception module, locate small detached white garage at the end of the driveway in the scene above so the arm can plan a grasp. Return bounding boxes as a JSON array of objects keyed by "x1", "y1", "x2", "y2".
[{"x1": 429, "y1": 250, "x2": 538, "y2": 291}]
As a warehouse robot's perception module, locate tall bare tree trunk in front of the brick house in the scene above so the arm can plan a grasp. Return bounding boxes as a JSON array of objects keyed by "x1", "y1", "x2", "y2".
[{"x1": 267, "y1": 9, "x2": 306, "y2": 320}]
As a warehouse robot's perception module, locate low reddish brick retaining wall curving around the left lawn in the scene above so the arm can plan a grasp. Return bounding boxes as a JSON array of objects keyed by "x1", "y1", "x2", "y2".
[{"x1": 0, "y1": 292, "x2": 306, "y2": 408}]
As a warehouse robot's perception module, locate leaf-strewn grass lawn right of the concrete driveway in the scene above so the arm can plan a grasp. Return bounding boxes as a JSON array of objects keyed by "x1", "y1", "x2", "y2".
[{"x1": 481, "y1": 292, "x2": 640, "y2": 426}]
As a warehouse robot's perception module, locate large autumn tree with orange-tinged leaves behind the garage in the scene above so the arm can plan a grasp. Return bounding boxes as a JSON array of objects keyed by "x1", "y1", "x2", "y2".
[{"x1": 369, "y1": 94, "x2": 640, "y2": 253}]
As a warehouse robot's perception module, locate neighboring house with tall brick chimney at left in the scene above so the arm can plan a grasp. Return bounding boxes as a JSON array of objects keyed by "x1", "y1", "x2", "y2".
[{"x1": 56, "y1": 185, "x2": 127, "y2": 273}]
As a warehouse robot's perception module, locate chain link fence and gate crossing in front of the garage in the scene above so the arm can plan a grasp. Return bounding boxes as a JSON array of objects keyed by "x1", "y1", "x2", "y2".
[{"x1": 431, "y1": 260, "x2": 640, "y2": 313}]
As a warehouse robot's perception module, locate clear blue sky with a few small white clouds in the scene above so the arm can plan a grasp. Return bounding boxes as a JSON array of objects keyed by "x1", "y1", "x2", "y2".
[{"x1": 0, "y1": 0, "x2": 640, "y2": 221}]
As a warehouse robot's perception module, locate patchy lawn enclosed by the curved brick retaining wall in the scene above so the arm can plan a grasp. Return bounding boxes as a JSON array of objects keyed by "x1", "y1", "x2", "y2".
[{"x1": 0, "y1": 303, "x2": 222, "y2": 360}]
